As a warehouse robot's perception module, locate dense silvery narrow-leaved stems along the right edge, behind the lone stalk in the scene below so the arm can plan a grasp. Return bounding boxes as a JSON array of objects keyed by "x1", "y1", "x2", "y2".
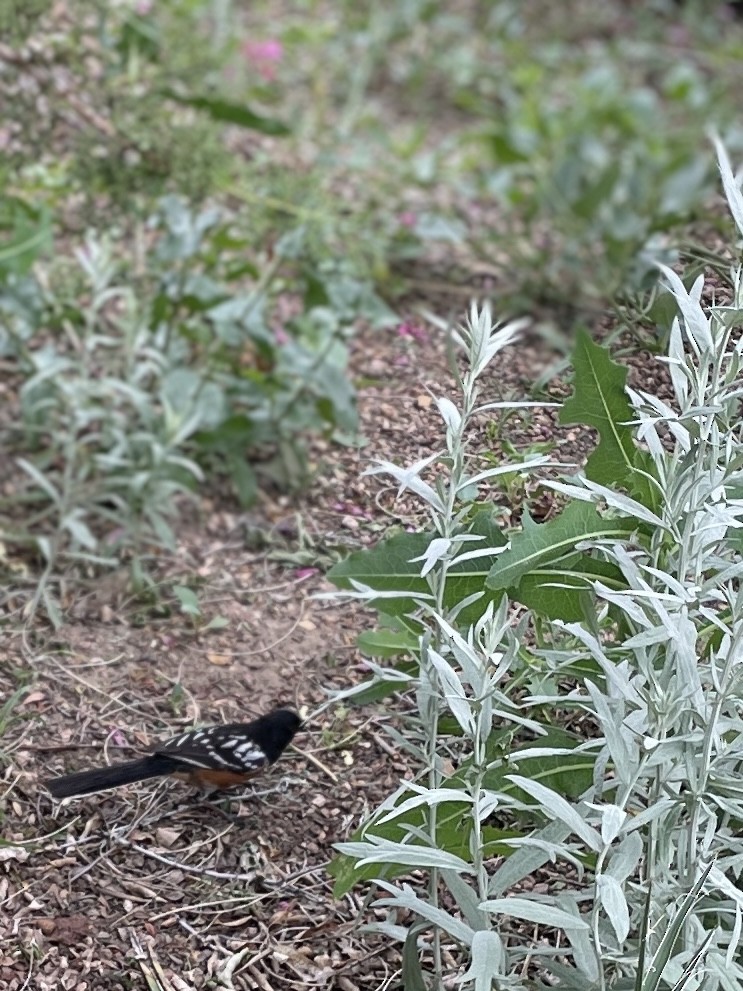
[{"x1": 512, "y1": 138, "x2": 743, "y2": 989}]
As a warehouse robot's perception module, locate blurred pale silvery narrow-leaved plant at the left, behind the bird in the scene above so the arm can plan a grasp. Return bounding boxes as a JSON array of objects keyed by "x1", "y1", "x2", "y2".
[{"x1": 13, "y1": 237, "x2": 205, "y2": 625}]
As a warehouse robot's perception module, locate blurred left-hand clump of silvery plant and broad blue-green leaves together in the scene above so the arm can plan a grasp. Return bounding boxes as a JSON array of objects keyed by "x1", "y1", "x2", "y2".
[{"x1": 0, "y1": 197, "x2": 389, "y2": 620}]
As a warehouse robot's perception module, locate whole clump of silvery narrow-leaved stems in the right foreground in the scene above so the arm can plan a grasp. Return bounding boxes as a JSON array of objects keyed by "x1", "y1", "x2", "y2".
[{"x1": 330, "y1": 145, "x2": 743, "y2": 991}]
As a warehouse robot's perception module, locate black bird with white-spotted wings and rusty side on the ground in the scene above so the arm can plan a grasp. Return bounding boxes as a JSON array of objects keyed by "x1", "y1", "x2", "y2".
[{"x1": 44, "y1": 709, "x2": 301, "y2": 798}]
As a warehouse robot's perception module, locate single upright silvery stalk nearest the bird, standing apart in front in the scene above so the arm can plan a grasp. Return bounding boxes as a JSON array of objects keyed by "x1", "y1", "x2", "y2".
[{"x1": 332, "y1": 306, "x2": 564, "y2": 988}]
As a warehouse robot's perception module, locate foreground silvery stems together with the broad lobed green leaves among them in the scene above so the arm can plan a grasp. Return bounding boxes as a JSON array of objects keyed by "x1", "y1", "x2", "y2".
[{"x1": 331, "y1": 141, "x2": 743, "y2": 991}]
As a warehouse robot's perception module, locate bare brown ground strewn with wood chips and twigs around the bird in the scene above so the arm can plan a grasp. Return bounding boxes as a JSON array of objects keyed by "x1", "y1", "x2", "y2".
[{"x1": 0, "y1": 302, "x2": 680, "y2": 991}]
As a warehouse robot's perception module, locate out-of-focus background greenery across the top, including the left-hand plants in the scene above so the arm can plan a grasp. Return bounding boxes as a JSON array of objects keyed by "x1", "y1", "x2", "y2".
[{"x1": 0, "y1": 0, "x2": 743, "y2": 604}]
